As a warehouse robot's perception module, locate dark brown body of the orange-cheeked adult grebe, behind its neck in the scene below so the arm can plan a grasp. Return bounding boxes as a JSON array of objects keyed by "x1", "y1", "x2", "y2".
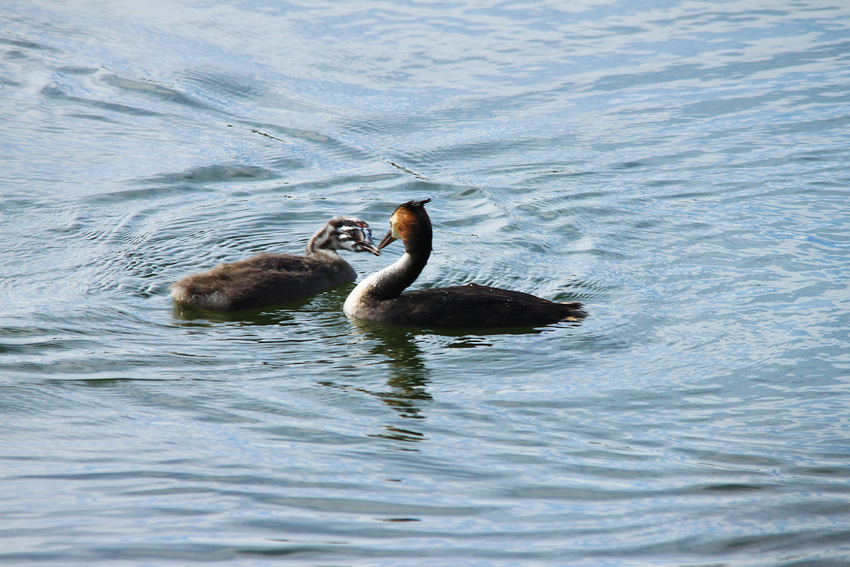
[{"x1": 378, "y1": 284, "x2": 586, "y2": 328}]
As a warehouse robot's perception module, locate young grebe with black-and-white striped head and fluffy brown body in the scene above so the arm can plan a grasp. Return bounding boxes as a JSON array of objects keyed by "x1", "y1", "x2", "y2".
[{"x1": 171, "y1": 217, "x2": 381, "y2": 311}]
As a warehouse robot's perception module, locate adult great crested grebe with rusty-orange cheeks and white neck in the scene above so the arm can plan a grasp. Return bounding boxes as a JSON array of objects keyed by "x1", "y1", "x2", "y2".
[{"x1": 344, "y1": 199, "x2": 586, "y2": 328}]
